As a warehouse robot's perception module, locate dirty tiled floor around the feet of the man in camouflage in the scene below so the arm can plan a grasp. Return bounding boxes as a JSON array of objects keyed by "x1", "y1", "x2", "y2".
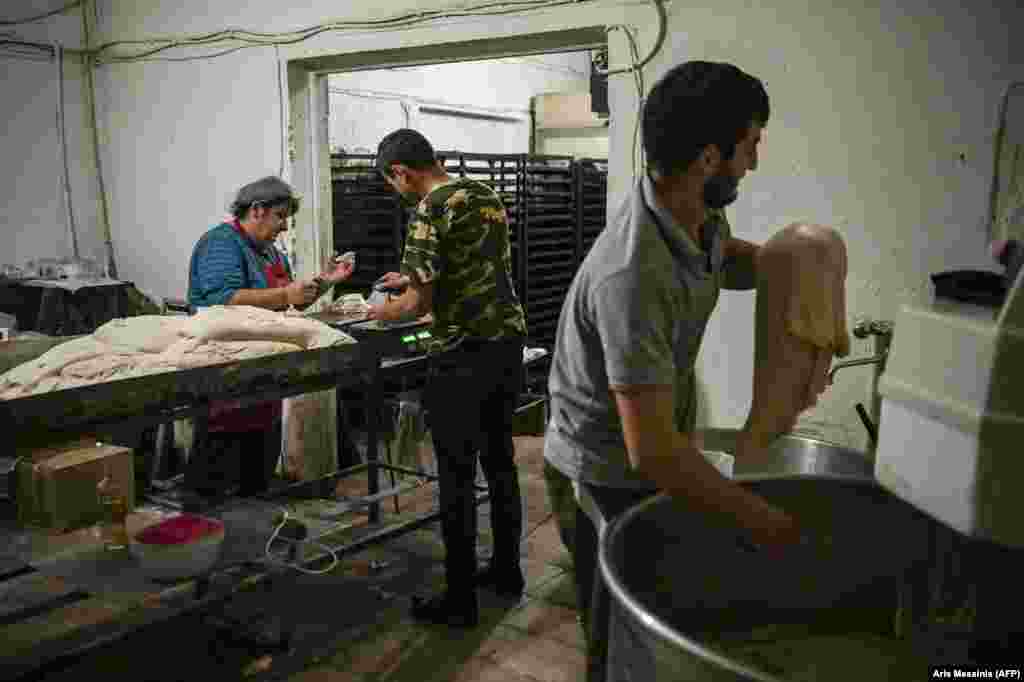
[{"x1": 32, "y1": 437, "x2": 585, "y2": 682}]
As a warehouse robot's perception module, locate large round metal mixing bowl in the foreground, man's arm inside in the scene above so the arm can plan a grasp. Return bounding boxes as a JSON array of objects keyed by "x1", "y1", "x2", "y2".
[{"x1": 599, "y1": 475, "x2": 967, "y2": 682}]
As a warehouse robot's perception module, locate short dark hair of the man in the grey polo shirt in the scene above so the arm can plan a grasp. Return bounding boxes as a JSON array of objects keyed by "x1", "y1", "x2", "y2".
[{"x1": 643, "y1": 61, "x2": 770, "y2": 176}]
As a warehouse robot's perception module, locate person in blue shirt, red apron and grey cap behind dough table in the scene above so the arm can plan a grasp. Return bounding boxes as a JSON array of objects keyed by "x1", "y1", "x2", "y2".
[{"x1": 185, "y1": 176, "x2": 353, "y2": 496}]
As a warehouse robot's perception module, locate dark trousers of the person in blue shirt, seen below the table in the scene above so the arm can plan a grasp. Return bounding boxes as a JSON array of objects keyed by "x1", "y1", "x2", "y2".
[{"x1": 184, "y1": 419, "x2": 281, "y2": 497}]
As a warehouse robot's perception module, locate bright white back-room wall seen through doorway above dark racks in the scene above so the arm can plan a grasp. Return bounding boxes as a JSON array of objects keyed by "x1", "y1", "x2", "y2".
[{"x1": 330, "y1": 52, "x2": 590, "y2": 154}]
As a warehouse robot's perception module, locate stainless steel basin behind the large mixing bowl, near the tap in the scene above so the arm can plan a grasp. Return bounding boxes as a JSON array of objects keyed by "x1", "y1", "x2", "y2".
[{"x1": 700, "y1": 429, "x2": 873, "y2": 478}]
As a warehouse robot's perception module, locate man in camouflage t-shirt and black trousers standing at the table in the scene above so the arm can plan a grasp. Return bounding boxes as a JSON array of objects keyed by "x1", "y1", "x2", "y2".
[{"x1": 370, "y1": 129, "x2": 526, "y2": 627}]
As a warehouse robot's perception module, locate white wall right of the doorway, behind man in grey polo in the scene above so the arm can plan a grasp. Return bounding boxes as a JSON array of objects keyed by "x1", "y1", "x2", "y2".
[{"x1": 612, "y1": 0, "x2": 1024, "y2": 446}]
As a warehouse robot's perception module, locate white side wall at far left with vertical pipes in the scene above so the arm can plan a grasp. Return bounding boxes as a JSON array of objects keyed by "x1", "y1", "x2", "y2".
[{"x1": 0, "y1": 2, "x2": 103, "y2": 265}]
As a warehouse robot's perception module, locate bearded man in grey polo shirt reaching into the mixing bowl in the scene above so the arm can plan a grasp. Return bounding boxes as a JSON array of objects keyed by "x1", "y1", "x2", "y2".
[{"x1": 544, "y1": 61, "x2": 799, "y2": 682}]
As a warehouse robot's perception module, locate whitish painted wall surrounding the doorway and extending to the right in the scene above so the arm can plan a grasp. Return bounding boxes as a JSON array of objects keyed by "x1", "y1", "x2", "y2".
[{"x1": 8, "y1": 0, "x2": 1024, "y2": 445}]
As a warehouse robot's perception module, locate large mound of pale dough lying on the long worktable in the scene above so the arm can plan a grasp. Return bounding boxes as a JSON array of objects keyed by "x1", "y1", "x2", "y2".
[{"x1": 0, "y1": 306, "x2": 355, "y2": 400}]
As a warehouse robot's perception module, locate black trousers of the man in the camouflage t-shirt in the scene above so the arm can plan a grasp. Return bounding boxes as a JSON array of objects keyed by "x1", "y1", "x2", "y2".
[{"x1": 424, "y1": 339, "x2": 523, "y2": 595}]
